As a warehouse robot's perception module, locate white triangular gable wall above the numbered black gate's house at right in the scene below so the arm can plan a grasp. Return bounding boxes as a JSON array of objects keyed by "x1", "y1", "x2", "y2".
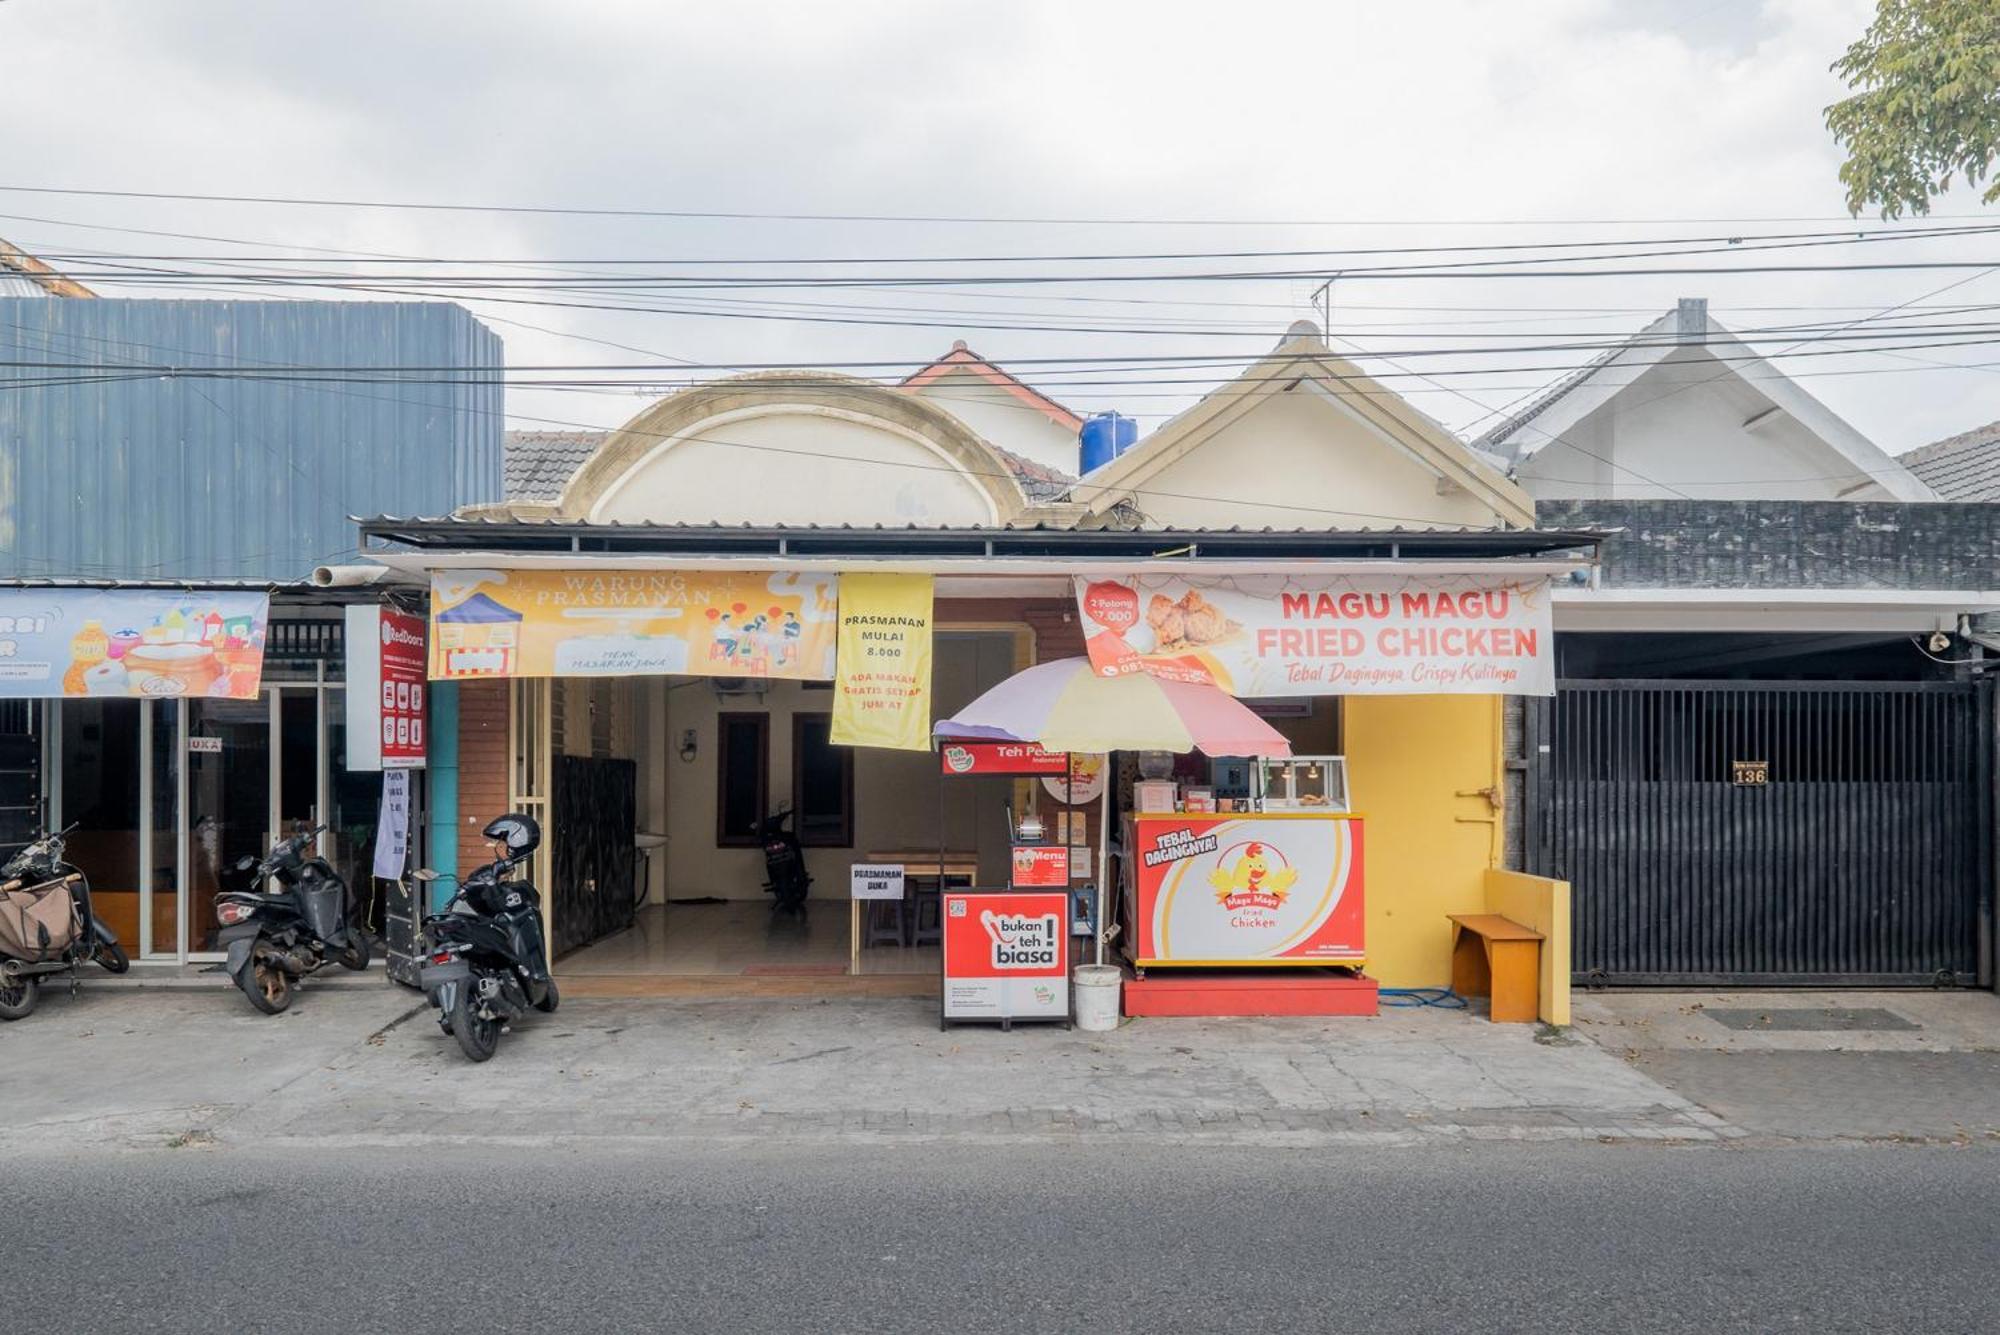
[{"x1": 1516, "y1": 352, "x2": 1890, "y2": 500}]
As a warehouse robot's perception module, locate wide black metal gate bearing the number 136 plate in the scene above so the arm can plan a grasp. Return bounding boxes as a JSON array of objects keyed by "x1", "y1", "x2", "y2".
[{"x1": 1526, "y1": 681, "x2": 1994, "y2": 985}]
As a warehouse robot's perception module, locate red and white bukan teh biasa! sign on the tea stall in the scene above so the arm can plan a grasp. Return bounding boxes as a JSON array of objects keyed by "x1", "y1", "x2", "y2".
[{"x1": 944, "y1": 889, "x2": 1070, "y2": 1021}]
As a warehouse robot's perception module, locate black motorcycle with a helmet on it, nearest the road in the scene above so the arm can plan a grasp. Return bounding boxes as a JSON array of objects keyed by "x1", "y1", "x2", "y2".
[{"x1": 418, "y1": 813, "x2": 562, "y2": 1061}]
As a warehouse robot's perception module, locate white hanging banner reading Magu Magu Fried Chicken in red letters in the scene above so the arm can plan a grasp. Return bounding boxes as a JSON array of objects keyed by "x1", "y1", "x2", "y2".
[{"x1": 1076, "y1": 576, "x2": 1556, "y2": 695}]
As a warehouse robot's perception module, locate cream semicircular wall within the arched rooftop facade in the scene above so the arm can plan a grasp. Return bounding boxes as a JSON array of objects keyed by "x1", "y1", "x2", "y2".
[{"x1": 590, "y1": 408, "x2": 998, "y2": 526}]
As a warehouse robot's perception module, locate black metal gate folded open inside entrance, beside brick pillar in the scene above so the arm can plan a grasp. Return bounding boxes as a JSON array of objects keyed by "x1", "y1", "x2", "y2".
[{"x1": 550, "y1": 755, "x2": 638, "y2": 955}]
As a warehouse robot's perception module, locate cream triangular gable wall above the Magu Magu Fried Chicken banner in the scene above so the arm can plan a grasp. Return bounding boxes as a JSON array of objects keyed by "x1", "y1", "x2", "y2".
[{"x1": 1132, "y1": 388, "x2": 1494, "y2": 528}]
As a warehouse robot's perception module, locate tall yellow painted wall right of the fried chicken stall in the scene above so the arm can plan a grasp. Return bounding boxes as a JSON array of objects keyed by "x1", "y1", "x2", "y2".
[{"x1": 1344, "y1": 695, "x2": 1502, "y2": 987}]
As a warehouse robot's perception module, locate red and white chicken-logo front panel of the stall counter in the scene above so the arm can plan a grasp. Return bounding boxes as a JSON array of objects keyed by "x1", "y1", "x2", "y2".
[{"x1": 1128, "y1": 813, "x2": 1364, "y2": 967}]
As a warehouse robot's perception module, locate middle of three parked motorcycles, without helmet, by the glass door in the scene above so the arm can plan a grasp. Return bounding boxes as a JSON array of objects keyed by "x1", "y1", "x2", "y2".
[{"x1": 216, "y1": 825, "x2": 368, "y2": 1015}]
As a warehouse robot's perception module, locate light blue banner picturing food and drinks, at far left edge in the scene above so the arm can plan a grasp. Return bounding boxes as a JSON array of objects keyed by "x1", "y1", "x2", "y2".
[{"x1": 0, "y1": 588, "x2": 270, "y2": 699}]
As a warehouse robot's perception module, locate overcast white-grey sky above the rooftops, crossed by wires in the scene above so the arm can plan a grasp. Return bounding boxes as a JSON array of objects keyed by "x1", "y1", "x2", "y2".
[{"x1": 0, "y1": 0, "x2": 2000, "y2": 452}]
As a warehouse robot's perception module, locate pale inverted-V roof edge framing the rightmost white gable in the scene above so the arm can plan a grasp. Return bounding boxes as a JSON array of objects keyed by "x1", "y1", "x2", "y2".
[{"x1": 1472, "y1": 298, "x2": 1936, "y2": 500}]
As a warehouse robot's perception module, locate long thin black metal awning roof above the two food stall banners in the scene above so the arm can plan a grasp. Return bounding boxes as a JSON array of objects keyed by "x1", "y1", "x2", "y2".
[{"x1": 358, "y1": 516, "x2": 1610, "y2": 562}]
